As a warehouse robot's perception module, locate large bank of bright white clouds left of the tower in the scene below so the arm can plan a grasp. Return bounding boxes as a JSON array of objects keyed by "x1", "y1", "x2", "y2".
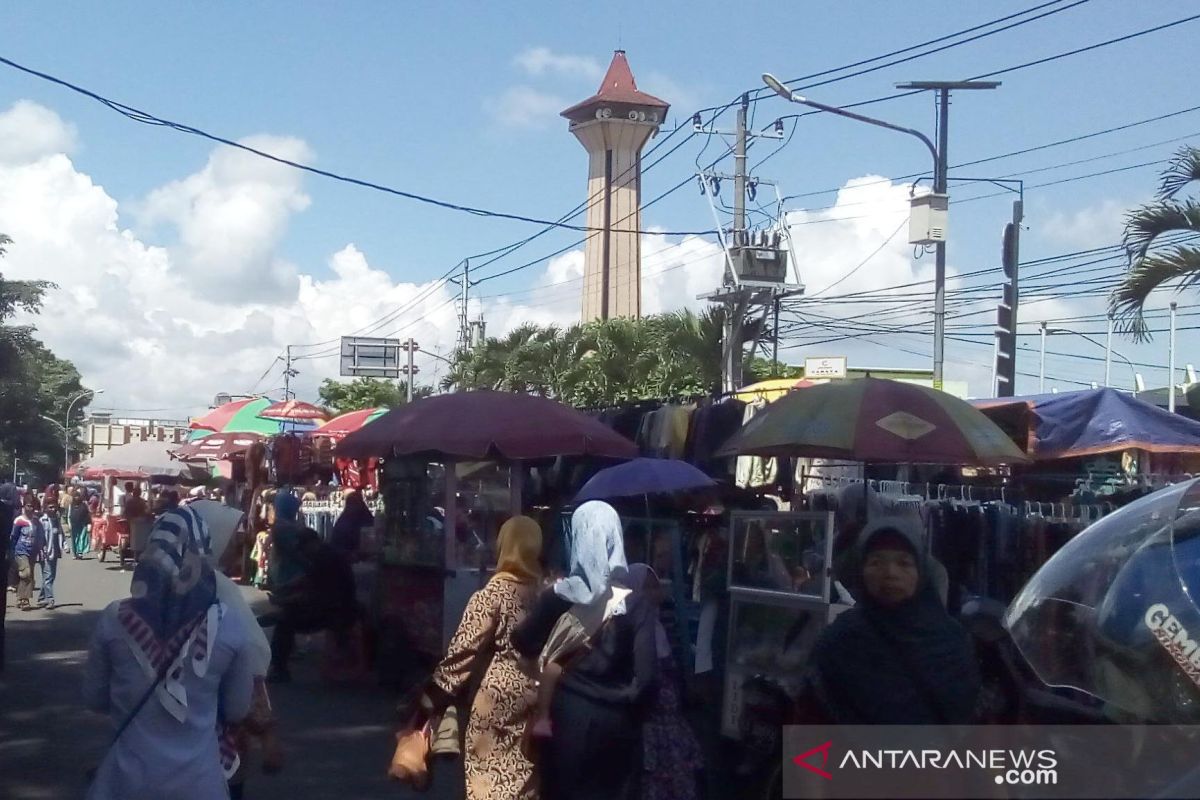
[{"x1": 0, "y1": 100, "x2": 455, "y2": 416}]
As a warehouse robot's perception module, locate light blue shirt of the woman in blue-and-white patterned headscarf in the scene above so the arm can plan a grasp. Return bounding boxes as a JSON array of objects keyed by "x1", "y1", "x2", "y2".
[{"x1": 83, "y1": 601, "x2": 254, "y2": 800}]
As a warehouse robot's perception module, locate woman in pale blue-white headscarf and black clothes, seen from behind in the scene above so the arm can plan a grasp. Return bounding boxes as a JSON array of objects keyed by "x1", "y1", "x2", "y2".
[{"x1": 512, "y1": 500, "x2": 655, "y2": 800}]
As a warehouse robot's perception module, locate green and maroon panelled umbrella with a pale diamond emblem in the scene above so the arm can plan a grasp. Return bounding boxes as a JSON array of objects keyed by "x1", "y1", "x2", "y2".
[{"x1": 721, "y1": 378, "x2": 1028, "y2": 467}]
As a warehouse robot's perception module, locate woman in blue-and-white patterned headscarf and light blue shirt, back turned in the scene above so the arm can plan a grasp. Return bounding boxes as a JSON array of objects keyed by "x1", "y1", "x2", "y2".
[{"x1": 83, "y1": 507, "x2": 253, "y2": 800}]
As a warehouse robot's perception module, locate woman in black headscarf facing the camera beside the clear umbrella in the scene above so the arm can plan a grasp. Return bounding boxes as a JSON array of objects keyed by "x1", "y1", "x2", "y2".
[{"x1": 799, "y1": 517, "x2": 979, "y2": 724}]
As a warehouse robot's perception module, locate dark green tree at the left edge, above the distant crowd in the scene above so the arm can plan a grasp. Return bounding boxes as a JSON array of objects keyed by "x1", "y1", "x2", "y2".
[{"x1": 0, "y1": 234, "x2": 86, "y2": 483}]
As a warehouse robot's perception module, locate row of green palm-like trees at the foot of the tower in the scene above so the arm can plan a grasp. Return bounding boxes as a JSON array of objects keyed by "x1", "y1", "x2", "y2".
[{"x1": 443, "y1": 306, "x2": 754, "y2": 407}]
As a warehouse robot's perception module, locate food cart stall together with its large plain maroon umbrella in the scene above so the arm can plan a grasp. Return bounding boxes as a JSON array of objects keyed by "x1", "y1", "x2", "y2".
[{"x1": 335, "y1": 391, "x2": 637, "y2": 660}]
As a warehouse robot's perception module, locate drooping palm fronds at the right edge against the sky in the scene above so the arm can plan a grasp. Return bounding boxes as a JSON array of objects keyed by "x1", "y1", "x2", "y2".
[{"x1": 1109, "y1": 146, "x2": 1200, "y2": 341}]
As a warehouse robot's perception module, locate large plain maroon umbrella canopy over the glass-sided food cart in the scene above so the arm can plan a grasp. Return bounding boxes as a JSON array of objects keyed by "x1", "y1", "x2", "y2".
[{"x1": 336, "y1": 391, "x2": 637, "y2": 461}]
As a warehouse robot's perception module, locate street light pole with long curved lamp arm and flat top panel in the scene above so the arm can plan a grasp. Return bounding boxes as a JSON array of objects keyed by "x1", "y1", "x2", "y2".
[{"x1": 762, "y1": 72, "x2": 1000, "y2": 390}]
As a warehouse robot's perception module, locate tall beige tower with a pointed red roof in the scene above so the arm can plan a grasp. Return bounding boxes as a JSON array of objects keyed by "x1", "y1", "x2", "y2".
[{"x1": 563, "y1": 50, "x2": 670, "y2": 323}]
